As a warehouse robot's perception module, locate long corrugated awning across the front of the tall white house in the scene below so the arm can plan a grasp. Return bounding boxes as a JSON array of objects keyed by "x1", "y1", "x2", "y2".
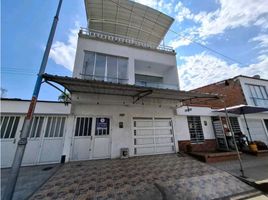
[{"x1": 43, "y1": 74, "x2": 218, "y2": 103}]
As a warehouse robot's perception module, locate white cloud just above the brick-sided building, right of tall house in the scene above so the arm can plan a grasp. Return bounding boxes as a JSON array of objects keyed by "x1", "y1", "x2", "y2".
[{"x1": 178, "y1": 52, "x2": 268, "y2": 90}]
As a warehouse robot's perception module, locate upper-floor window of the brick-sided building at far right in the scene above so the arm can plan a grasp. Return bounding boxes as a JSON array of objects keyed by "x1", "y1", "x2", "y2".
[{"x1": 248, "y1": 84, "x2": 268, "y2": 107}]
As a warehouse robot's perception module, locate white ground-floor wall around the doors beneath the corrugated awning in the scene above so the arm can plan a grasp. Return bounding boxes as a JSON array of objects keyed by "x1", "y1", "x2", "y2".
[{"x1": 71, "y1": 94, "x2": 180, "y2": 158}]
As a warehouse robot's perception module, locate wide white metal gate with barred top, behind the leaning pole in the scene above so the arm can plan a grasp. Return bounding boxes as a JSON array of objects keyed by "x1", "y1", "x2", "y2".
[{"x1": 0, "y1": 115, "x2": 66, "y2": 168}]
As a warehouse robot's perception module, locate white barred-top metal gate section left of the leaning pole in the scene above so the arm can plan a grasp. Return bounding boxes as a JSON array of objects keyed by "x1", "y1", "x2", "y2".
[{"x1": 0, "y1": 115, "x2": 21, "y2": 168}]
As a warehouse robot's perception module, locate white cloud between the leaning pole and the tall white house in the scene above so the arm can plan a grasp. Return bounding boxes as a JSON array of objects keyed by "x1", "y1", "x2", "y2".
[{"x1": 49, "y1": 22, "x2": 79, "y2": 71}]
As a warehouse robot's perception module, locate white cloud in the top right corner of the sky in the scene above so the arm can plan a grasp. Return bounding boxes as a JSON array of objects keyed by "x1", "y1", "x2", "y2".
[{"x1": 174, "y1": 0, "x2": 268, "y2": 39}]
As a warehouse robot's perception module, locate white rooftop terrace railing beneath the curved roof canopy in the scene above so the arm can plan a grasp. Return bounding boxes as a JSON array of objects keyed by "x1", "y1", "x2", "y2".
[{"x1": 79, "y1": 28, "x2": 175, "y2": 53}]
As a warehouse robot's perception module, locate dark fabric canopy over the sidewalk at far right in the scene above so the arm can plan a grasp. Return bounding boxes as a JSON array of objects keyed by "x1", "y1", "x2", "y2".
[{"x1": 214, "y1": 104, "x2": 268, "y2": 115}]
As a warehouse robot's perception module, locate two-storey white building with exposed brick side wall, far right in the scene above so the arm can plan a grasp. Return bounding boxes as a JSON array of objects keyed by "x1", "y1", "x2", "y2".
[{"x1": 191, "y1": 75, "x2": 268, "y2": 145}]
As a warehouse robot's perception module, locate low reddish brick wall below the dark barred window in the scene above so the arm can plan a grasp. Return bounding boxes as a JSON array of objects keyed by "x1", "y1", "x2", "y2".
[{"x1": 178, "y1": 139, "x2": 217, "y2": 152}]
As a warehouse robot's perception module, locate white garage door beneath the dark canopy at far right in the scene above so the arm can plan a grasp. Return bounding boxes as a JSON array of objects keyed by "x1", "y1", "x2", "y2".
[{"x1": 242, "y1": 119, "x2": 268, "y2": 145}]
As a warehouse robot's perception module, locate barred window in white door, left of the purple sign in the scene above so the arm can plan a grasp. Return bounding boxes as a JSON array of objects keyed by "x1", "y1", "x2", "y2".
[{"x1": 75, "y1": 117, "x2": 92, "y2": 136}]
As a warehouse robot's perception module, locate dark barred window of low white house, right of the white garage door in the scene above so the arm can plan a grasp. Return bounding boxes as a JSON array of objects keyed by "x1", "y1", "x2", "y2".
[{"x1": 187, "y1": 116, "x2": 204, "y2": 143}]
